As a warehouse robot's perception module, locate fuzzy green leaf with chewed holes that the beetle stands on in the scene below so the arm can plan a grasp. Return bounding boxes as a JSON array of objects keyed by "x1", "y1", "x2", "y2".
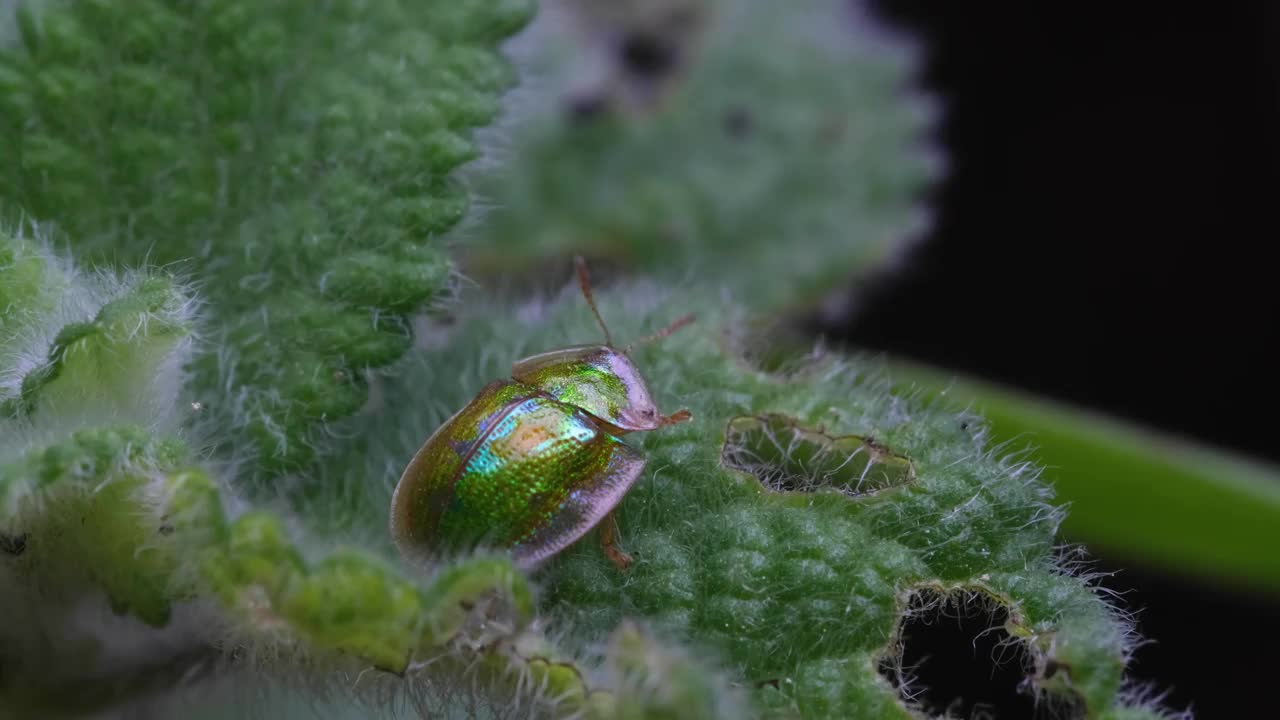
[{"x1": 307, "y1": 287, "x2": 1167, "y2": 717}]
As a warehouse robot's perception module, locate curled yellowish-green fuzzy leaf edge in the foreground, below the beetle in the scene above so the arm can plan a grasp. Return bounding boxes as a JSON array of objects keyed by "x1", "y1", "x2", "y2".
[{"x1": 0, "y1": 427, "x2": 723, "y2": 719}]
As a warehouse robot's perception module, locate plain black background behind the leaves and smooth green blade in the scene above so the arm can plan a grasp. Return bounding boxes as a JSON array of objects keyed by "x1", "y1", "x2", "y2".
[{"x1": 827, "y1": 0, "x2": 1280, "y2": 717}]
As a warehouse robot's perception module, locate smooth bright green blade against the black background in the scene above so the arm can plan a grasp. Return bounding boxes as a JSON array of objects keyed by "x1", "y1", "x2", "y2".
[{"x1": 890, "y1": 360, "x2": 1280, "y2": 591}]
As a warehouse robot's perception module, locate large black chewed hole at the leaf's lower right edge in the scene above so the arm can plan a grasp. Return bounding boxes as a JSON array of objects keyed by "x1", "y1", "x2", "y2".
[{"x1": 879, "y1": 589, "x2": 1083, "y2": 720}]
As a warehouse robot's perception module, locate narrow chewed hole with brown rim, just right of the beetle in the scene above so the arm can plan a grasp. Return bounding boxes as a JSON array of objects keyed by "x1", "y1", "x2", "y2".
[{"x1": 722, "y1": 414, "x2": 915, "y2": 496}]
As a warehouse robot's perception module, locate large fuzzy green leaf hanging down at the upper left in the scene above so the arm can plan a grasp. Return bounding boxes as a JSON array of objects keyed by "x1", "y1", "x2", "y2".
[{"x1": 0, "y1": 0, "x2": 530, "y2": 470}]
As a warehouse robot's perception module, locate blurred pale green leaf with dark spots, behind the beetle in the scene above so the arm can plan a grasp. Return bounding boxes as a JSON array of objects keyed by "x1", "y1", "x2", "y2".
[{"x1": 462, "y1": 0, "x2": 940, "y2": 313}]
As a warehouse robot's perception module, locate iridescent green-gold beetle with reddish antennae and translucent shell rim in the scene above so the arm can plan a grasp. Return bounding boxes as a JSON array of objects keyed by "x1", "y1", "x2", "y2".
[{"x1": 390, "y1": 258, "x2": 694, "y2": 570}]
